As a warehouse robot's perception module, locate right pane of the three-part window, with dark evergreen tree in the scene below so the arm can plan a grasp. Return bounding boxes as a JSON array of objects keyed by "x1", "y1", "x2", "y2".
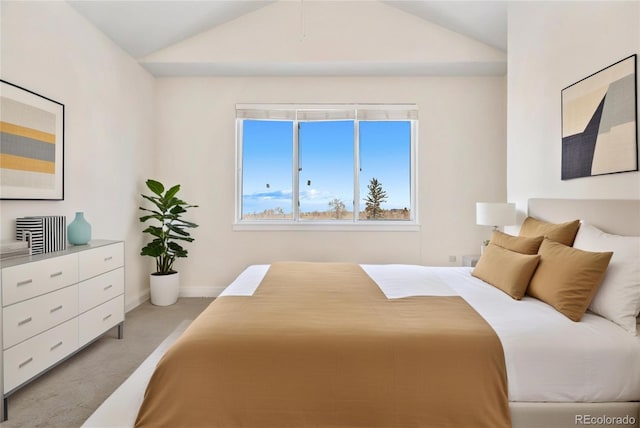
[{"x1": 359, "y1": 121, "x2": 411, "y2": 220}]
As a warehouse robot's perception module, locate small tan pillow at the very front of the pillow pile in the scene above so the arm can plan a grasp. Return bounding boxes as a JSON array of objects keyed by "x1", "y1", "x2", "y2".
[{"x1": 471, "y1": 243, "x2": 540, "y2": 300}]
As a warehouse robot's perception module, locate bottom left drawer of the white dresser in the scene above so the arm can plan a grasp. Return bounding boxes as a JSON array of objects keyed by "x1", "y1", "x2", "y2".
[{"x1": 4, "y1": 318, "x2": 78, "y2": 394}]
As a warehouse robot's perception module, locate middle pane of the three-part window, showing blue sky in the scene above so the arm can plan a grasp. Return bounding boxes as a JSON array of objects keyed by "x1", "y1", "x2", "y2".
[{"x1": 298, "y1": 120, "x2": 354, "y2": 220}]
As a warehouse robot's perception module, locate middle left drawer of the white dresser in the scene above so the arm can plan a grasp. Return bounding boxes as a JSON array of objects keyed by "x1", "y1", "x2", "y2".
[{"x1": 2, "y1": 284, "x2": 78, "y2": 349}]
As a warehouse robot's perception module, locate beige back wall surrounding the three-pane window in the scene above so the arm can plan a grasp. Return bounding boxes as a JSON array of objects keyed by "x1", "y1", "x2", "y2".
[{"x1": 156, "y1": 77, "x2": 506, "y2": 294}]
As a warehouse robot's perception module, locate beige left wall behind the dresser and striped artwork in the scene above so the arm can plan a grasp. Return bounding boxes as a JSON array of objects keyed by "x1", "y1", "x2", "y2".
[{"x1": 0, "y1": 1, "x2": 155, "y2": 309}]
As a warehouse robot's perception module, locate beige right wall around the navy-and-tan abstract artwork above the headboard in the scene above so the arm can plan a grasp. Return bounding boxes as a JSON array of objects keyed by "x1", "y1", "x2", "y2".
[{"x1": 507, "y1": 1, "x2": 640, "y2": 224}]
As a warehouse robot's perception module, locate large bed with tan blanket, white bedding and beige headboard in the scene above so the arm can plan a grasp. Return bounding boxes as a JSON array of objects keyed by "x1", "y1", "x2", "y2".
[{"x1": 136, "y1": 200, "x2": 640, "y2": 428}]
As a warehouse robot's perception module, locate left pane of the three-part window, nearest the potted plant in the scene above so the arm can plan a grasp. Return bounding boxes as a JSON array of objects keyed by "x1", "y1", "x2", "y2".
[{"x1": 242, "y1": 120, "x2": 293, "y2": 220}]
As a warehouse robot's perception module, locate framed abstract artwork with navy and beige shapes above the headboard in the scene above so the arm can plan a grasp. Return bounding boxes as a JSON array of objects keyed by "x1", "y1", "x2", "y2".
[{"x1": 562, "y1": 54, "x2": 638, "y2": 180}]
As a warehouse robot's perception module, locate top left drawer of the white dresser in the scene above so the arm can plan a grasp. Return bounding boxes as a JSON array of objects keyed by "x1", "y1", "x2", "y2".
[{"x1": 2, "y1": 254, "x2": 78, "y2": 306}]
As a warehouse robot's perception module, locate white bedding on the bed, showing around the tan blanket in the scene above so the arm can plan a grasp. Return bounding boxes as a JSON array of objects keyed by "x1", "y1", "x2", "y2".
[{"x1": 220, "y1": 265, "x2": 640, "y2": 402}]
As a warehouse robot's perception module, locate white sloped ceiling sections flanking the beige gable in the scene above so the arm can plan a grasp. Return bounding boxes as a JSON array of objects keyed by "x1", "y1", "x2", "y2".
[{"x1": 67, "y1": 0, "x2": 507, "y2": 75}]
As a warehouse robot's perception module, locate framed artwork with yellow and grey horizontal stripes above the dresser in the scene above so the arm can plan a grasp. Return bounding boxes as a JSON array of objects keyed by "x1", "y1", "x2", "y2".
[{"x1": 0, "y1": 80, "x2": 64, "y2": 200}]
